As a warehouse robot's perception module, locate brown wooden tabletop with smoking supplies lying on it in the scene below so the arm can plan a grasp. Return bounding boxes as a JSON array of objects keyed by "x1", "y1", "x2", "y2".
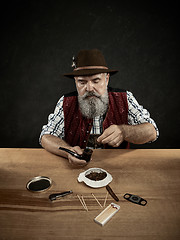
[{"x1": 0, "y1": 149, "x2": 180, "y2": 240}]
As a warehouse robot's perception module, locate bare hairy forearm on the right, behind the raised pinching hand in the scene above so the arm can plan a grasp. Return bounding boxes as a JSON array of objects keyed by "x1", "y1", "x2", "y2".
[{"x1": 120, "y1": 123, "x2": 156, "y2": 144}]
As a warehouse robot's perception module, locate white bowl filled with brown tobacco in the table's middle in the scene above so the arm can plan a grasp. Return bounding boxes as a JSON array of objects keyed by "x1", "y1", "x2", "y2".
[{"x1": 78, "y1": 168, "x2": 113, "y2": 188}]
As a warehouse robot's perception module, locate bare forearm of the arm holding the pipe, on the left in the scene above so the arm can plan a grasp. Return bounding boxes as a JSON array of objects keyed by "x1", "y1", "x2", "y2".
[{"x1": 41, "y1": 134, "x2": 70, "y2": 158}]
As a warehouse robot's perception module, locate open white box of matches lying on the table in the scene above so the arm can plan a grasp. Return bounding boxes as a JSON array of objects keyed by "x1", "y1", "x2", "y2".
[{"x1": 94, "y1": 203, "x2": 120, "y2": 226}]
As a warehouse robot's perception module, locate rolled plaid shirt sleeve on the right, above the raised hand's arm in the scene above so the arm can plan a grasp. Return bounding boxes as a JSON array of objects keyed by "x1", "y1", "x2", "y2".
[{"x1": 127, "y1": 91, "x2": 159, "y2": 139}]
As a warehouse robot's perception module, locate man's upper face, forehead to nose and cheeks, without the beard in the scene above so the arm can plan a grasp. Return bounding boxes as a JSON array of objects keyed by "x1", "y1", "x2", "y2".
[{"x1": 75, "y1": 73, "x2": 109, "y2": 96}]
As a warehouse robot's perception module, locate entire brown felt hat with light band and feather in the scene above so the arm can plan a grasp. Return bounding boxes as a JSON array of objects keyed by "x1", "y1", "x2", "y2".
[{"x1": 64, "y1": 49, "x2": 118, "y2": 78}]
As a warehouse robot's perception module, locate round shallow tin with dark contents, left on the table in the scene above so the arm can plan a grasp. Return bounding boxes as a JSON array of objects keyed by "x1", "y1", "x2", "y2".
[{"x1": 26, "y1": 176, "x2": 52, "y2": 192}]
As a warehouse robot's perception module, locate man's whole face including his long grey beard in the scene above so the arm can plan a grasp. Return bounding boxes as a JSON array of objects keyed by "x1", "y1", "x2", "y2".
[{"x1": 75, "y1": 73, "x2": 109, "y2": 118}]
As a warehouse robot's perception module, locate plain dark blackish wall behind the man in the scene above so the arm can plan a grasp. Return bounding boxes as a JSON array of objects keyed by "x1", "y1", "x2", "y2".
[{"x1": 0, "y1": 0, "x2": 180, "y2": 148}]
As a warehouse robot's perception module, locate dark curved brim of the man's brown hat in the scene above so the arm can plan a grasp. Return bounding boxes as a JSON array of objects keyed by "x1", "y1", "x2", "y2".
[{"x1": 63, "y1": 69, "x2": 118, "y2": 78}]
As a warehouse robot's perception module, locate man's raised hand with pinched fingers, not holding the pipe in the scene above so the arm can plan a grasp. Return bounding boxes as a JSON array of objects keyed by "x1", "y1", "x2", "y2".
[{"x1": 97, "y1": 125, "x2": 124, "y2": 147}]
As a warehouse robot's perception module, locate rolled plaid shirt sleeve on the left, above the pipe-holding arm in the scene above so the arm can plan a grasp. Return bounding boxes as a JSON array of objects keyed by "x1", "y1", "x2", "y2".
[{"x1": 39, "y1": 96, "x2": 64, "y2": 144}]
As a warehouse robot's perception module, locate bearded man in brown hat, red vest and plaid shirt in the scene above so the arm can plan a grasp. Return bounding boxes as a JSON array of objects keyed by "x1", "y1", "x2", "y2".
[{"x1": 40, "y1": 49, "x2": 159, "y2": 166}]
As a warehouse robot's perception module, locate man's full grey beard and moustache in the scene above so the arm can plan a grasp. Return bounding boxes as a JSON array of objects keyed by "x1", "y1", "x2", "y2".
[{"x1": 78, "y1": 91, "x2": 109, "y2": 118}]
